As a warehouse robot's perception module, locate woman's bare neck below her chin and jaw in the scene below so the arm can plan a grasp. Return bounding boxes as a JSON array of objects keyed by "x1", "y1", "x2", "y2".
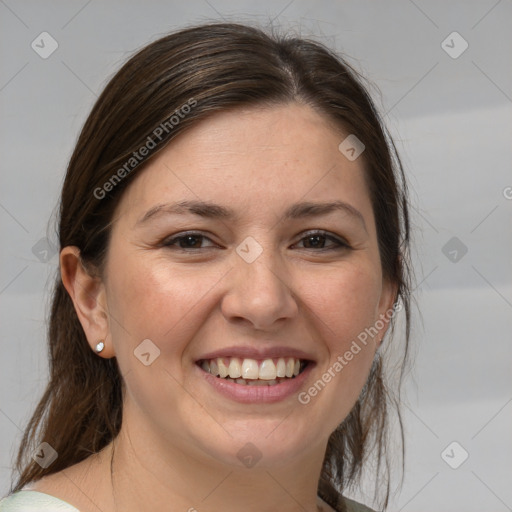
[{"x1": 108, "y1": 412, "x2": 325, "y2": 512}]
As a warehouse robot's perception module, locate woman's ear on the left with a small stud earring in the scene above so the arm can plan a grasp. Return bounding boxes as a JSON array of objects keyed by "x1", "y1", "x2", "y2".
[{"x1": 60, "y1": 246, "x2": 115, "y2": 358}]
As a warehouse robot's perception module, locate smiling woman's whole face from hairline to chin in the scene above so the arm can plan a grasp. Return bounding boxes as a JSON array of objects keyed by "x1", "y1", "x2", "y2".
[{"x1": 104, "y1": 103, "x2": 394, "y2": 466}]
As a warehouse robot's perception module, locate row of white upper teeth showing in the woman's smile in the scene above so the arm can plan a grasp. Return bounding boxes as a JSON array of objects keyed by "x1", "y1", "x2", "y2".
[{"x1": 201, "y1": 357, "x2": 300, "y2": 380}]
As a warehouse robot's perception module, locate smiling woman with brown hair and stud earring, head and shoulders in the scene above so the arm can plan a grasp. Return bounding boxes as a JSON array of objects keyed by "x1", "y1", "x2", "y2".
[{"x1": 0, "y1": 24, "x2": 410, "y2": 512}]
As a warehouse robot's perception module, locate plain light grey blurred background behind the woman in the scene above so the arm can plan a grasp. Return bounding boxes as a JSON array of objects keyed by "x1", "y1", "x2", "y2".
[{"x1": 0, "y1": 0, "x2": 512, "y2": 512}]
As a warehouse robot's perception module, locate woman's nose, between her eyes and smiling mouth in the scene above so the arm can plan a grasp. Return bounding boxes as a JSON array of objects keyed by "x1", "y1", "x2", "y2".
[{"x1": 221, "y1": 249, "x2": 298, "y2": 331}]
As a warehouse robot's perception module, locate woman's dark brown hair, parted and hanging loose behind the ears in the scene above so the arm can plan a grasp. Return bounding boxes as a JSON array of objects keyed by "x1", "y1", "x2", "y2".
[{"x1": 12, "y1": 23, "x2": 410, "y2": 506}]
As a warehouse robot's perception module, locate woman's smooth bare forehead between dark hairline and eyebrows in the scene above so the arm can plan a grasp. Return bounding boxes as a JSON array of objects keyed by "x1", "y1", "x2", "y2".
[{"x1": 115, "y1": 103, "x2": 371, "y2": 224}]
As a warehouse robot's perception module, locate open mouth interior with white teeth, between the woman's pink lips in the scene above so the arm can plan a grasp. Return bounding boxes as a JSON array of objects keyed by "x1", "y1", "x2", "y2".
[{"x1": 196, "y1": 357, "x2": 312, "y2": 386}]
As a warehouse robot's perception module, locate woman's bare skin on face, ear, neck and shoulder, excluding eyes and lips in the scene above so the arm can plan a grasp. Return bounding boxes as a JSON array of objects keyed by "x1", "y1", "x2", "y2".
[{"x1": 36, "y1": 103, "x2": 395, "y2": 512}]
